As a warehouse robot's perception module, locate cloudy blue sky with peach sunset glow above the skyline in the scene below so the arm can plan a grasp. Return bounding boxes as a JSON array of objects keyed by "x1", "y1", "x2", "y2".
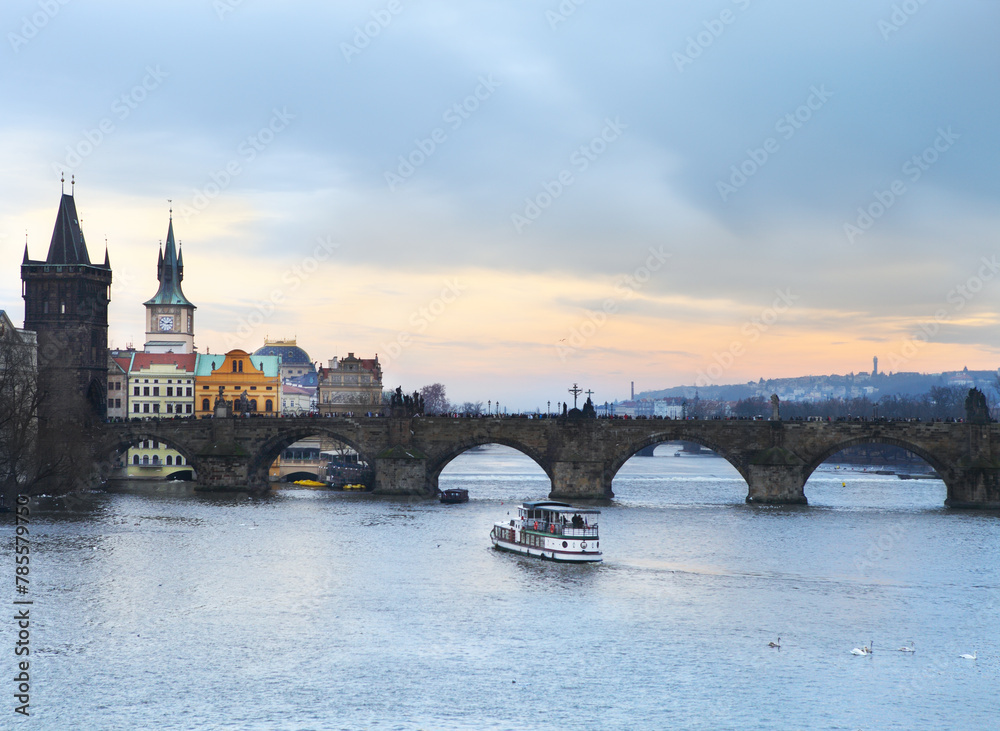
[{"x1": 0, "y1": 0, "x2": 1000, "y2": 411}]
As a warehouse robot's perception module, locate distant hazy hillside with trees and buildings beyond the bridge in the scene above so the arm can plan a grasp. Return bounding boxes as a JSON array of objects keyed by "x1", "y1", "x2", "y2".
[{"x1": 635, "y1": 369, "x2": 998, "y2": 401}]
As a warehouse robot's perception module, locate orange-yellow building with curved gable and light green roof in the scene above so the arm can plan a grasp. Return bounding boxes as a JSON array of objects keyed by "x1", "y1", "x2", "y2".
[{"x1": 194, "y1": 350, "x2": 281, "y2": 417}]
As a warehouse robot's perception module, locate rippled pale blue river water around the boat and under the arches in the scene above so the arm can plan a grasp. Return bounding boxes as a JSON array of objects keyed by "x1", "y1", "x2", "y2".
[{"x1": 0, "y1": 446, "x2": 1000, "y2": 731}]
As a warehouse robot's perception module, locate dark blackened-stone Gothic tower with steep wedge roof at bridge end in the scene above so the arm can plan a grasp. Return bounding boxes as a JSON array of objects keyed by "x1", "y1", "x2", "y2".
[{"x1": 21, "y1": 186, "x2": 111, "y2": 425}]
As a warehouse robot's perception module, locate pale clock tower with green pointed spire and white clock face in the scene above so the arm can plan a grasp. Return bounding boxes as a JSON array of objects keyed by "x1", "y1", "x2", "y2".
[{"x1": 143, "y1": 214, "x2": 195, "y2": 353}]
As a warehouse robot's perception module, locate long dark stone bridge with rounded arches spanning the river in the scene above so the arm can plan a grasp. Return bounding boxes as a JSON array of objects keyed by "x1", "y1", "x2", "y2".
[{"x1": 94, "y1": 416, "x2": 1000, "y2": 509}]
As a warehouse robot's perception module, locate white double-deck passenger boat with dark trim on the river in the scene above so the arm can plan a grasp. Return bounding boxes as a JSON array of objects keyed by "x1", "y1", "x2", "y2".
[{"x1": 490, "y1": 500, "x2": 603, "y2": 563}]
